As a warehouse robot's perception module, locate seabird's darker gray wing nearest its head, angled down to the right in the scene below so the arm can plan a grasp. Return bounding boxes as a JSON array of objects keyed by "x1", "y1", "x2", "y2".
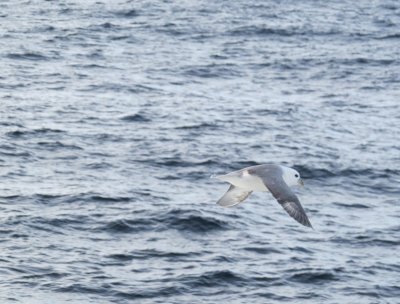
[{"x1": 262, "y1": 176, "x2": 312, "y2": 228}]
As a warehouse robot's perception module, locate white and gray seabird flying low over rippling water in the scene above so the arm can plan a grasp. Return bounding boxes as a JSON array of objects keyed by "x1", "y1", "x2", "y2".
[{"x1": 212, "y1": 164, "x2": 313, "y2": 228}]
